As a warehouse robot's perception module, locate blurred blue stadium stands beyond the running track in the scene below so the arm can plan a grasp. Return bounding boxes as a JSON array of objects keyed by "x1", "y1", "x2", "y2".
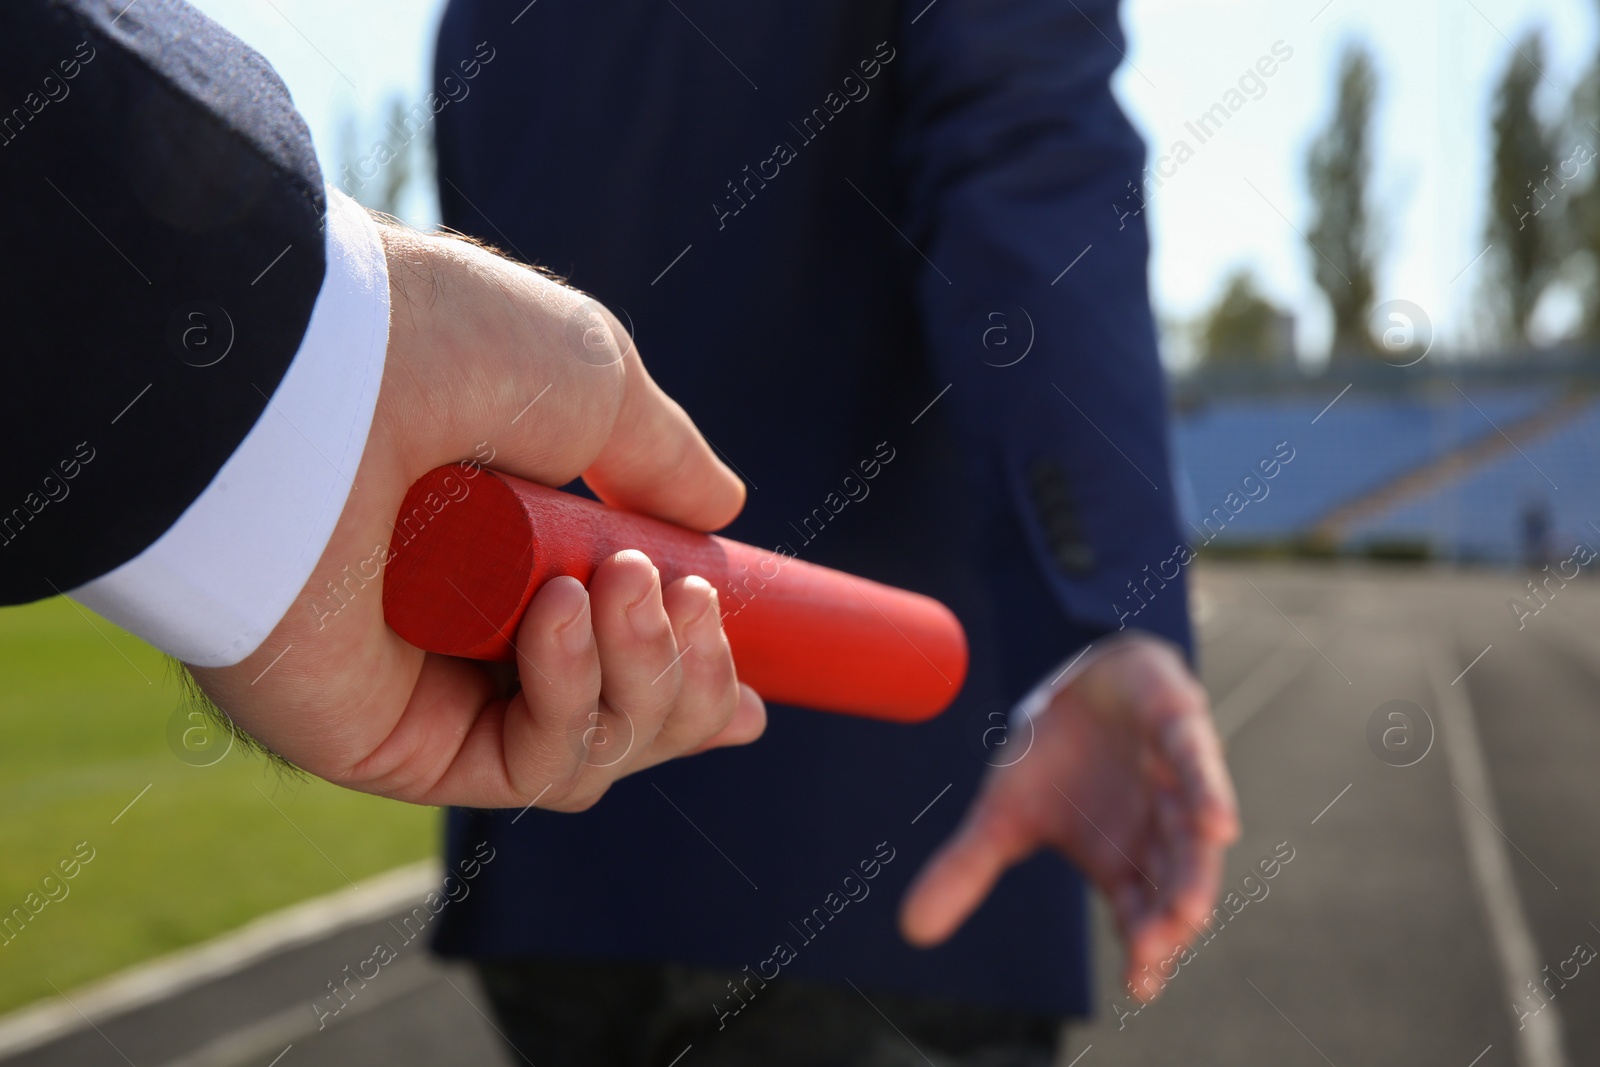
[{"x1": 1173, "y1": 358, "x2": 1600, "y2": 563}]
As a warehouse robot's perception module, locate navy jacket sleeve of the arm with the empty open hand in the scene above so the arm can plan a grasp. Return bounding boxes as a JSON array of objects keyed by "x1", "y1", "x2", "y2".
[{"x1": 894, "y1": 0, "x2": 1189, "y2": 653}]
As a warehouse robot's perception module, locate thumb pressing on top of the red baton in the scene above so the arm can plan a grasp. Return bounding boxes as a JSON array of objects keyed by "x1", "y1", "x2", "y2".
[{"x1": 584, "y1": 347, "x2": 744, "y2": 530}]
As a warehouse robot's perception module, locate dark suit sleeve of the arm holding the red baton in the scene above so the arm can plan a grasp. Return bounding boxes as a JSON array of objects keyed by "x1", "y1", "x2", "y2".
[{"x1": 0, "y1": 0, "x2": 326, "y2": 603}]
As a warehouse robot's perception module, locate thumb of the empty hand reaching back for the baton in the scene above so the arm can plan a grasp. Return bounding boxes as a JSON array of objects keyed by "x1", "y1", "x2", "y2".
[{"x1": 901, "y1": 793, "x2": 1038, "y2": 949}]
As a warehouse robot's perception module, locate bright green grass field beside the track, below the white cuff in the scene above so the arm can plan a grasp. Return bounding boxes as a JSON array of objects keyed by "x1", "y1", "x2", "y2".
[{"x1": 0, "y1": 598, "x2": 440, "y2": 1011}]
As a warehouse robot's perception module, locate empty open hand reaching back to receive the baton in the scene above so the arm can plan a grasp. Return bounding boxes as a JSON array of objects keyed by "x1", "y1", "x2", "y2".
[{"x1": 901, "y1": 635, "x2": 1238, "y2": 995}]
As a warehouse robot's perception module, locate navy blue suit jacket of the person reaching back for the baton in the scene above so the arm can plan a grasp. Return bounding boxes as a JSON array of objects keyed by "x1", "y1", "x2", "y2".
[{"x1": 437, "y1": 0, "x2": 1189, "y2": 1014}]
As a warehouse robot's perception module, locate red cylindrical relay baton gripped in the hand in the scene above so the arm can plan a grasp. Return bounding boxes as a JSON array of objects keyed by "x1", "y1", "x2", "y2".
[{"x1": 384, "y1": 464, "x2": 966, "y2": 723}]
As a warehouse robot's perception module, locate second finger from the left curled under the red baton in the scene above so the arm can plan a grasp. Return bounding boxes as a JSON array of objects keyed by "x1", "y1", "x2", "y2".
[{"x1": 589, "y1": 550, "x2": 678, "y2": 767}]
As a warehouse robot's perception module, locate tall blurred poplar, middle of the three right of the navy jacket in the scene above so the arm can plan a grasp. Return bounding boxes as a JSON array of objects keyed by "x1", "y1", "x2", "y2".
[{"x1": 1485, "y1": 32, "x2": 1565, "y2": 341}]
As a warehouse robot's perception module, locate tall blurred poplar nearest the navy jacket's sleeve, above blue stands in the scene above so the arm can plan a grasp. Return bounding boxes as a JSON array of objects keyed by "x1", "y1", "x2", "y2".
[{"x1": 1306, "y1": 42, "x2": 1378, "y2": 360}]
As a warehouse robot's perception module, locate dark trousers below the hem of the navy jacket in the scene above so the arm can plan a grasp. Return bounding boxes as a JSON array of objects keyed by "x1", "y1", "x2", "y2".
[{"x1": 478, "y1": 960, "x2": 1061, "y2": 1067}]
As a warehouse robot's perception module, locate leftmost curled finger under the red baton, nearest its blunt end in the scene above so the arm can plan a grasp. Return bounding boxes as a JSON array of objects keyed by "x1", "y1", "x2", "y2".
[{"x1": 504, "y1": 576, "x2": 600, "y2": 797}]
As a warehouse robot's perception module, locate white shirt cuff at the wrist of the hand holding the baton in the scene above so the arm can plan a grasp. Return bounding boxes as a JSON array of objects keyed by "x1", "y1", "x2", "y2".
[{"x1": 69, "y1": 186, "x2": 389, "y2": 667}]
